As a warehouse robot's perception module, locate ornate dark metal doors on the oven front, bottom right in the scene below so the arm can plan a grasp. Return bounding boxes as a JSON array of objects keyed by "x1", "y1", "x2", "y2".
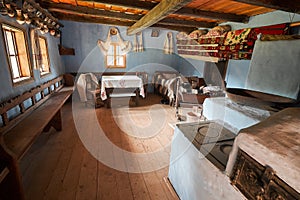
[{"x1": 231, "y1": 150, "x2": 300, "y2": 200}]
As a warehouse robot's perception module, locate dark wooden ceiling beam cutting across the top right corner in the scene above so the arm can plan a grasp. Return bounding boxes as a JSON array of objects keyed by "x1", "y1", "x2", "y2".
[{"x1": 233, "y1": 0, "x2": 300, "y2": 14}]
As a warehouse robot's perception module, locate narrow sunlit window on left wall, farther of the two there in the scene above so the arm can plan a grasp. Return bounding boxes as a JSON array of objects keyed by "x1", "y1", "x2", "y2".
[{"x1": 39, "y1": 36, "x2": 50, "y2": 75}]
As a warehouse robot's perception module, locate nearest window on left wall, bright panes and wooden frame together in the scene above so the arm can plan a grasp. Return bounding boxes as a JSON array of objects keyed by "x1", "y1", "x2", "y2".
[{"x1": 2, "y1": 24, "x2": 32, "y2": 83}]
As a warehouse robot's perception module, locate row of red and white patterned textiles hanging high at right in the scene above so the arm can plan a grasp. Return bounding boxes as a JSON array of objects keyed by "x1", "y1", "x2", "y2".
[{"x1": 176, "y1": 24, "x2": 288, "y2": 60}]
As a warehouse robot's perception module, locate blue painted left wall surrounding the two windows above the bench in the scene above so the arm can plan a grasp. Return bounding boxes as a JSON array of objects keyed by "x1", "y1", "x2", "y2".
[{"x1": 0, "y1": 15, "x2": 65, "y2": 102}]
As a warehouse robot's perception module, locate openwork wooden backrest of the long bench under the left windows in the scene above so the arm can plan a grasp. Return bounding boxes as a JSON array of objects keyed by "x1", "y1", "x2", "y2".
[{"x1": 0, "y1": 76, "x2": 64, "y2": 136}]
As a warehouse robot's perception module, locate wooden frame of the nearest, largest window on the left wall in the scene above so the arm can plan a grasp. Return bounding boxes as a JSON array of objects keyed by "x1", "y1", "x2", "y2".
[{"x1": 0, "y1": 21, "x2": 34, "y2": 86}]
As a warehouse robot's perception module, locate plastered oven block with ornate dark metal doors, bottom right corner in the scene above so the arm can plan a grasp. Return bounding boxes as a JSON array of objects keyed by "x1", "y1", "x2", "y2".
[{"x1": 227, "y1": 108, "x2": 300, "y2": 200}]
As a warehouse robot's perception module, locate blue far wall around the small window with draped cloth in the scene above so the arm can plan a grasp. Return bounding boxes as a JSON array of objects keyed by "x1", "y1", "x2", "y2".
[{"x1": 62, "y1": 21, "x2": 204, "y2": 76}]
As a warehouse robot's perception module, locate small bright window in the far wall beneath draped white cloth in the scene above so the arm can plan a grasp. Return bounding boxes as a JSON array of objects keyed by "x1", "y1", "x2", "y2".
[{"x1": 106, "y1": 43, "x2": 126, "y2": 68}]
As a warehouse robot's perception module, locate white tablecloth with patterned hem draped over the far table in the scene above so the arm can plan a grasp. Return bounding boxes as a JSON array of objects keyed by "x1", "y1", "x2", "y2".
[{"x1": 101, "y1": 75, "x2": 145, "y2": 100}]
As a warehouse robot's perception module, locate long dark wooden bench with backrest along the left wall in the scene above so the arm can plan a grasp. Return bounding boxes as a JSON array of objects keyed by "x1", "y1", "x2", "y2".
[{"x1": 0, "y1": 76, "x2": 73, "y2": 199}]
